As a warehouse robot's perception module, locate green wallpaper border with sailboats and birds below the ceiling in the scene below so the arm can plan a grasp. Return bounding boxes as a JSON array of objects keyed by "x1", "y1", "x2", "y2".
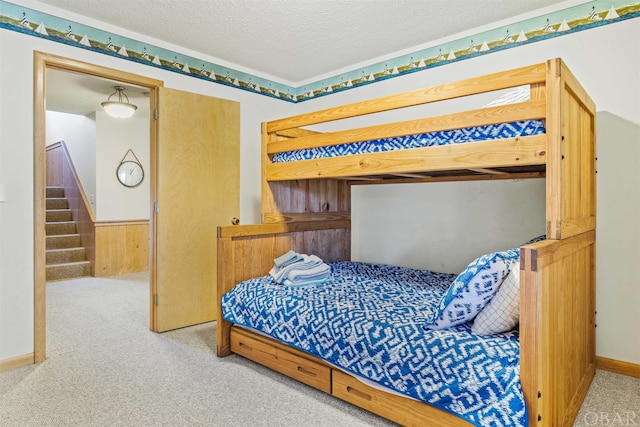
[{"x1": 0, "y1": 0, "x2": 640, "y2": 103}]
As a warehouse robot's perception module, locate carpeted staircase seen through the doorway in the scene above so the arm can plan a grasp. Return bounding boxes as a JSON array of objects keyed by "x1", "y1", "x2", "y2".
[{"x1": 45, "y1": 187, "x2": 91, "y2": 282}]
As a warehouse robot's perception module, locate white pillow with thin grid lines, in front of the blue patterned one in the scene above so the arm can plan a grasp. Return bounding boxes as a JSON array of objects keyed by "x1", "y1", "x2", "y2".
[{"x1": 471, "y1": 264, "x2": 520, "y2": 335}]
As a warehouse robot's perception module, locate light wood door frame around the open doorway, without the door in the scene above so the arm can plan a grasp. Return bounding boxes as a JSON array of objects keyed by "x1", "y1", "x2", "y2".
[{"x1": 33, "y1": 51, "x2": 164, "y2": 363}]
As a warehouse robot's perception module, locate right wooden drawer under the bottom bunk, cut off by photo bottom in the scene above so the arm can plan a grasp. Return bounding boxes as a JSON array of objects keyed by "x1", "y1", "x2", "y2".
[{"x1": 331, "y1": 369, "x2": 471, "y2": 427}]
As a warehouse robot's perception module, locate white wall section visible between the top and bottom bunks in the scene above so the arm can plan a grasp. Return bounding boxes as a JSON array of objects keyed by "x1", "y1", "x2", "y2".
[{"x1": 352, "y1": 179, "x2": 546, "y2": 273}]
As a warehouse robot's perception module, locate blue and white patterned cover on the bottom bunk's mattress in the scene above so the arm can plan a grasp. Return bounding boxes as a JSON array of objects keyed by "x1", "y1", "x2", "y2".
[{"x1": 222, "y1": 262, "x2": 527, "y2": 426}]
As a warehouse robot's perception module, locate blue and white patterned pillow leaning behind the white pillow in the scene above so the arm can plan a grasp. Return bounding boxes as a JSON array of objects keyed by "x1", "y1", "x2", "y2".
[{"x1": 425, "y1": 249, "x2": 520, "y2": 329}]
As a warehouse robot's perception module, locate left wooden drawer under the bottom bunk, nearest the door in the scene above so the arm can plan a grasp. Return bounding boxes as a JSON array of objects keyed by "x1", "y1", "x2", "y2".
[{"x1": 231, "y1": 328, "x2": 331, "y2": 393}]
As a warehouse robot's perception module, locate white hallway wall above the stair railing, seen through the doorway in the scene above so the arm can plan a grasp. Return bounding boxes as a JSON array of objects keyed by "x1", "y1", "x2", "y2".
[{"x1": 45, "y1": 111, "x2": 96, "y2": 215}]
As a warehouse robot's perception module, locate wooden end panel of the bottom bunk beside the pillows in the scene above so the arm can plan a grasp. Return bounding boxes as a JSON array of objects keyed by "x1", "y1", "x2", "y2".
[{"x1": 520, "y1": 234, "x2": 596, "y2": 427}]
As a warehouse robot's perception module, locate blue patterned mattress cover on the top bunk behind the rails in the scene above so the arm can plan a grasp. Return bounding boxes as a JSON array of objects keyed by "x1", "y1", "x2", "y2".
[{"x1": 271, "y1": 120, "x2": 545, "y2": 163}]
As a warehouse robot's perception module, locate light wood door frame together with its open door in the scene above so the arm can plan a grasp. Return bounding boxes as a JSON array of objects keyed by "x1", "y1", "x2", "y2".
[{"x1": 34, "y1": 52, "x2": 240, "y2": 363}]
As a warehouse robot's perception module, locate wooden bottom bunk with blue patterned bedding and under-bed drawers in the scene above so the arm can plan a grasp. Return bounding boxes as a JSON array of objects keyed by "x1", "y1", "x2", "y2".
[{"x1": 217, "y1": 223, "x2": 595, "y2": 426}]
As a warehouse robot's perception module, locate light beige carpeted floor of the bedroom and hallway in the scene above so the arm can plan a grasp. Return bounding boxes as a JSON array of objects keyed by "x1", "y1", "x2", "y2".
[{"x1": 0, "y1": 274, "x2": 640, "y2": 427}]
